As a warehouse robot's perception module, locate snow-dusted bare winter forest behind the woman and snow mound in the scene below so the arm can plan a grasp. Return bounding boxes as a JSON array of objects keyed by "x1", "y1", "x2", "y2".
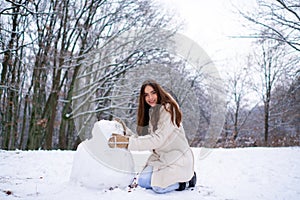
[{"x1": 0, "y1": 0, "x2": 300, "y2": 150}]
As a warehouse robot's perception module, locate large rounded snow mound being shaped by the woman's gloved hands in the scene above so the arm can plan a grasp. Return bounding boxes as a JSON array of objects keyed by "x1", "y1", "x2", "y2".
[{"x1": 70, "y1": 120, "x2": 134, "y2": 189}]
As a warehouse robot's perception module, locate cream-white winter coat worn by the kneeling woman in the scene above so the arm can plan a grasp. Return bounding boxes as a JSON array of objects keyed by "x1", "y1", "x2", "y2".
[{"x1": 128, "y1": 105, "x2": 194, "y2": 188}]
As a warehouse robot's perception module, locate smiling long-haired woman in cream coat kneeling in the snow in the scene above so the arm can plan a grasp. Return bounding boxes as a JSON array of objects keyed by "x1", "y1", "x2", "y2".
[{"x1": 109, "y1": 80, "x2": 196, "y2": 193}]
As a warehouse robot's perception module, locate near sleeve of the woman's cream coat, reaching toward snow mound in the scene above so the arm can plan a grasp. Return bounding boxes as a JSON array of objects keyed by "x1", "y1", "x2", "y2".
[{"x1": 128, "y1": 106, "x2": 176, "y2": 151}]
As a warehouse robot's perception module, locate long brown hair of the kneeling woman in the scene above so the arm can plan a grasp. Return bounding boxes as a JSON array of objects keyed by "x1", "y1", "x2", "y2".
[{"x1": 137, "y1": 80, "x2": 182, "y2": 135}]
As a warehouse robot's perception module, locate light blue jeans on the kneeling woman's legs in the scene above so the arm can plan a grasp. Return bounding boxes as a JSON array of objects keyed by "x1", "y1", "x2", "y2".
[{"x1": 138, "y1": 166, "x2": 179, "y2": 194}]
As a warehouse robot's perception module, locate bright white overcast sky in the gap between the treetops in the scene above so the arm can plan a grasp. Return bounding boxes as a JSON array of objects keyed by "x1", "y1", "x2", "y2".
[{"x1": 160, "y1": 0, "x2": 255, "y2": 71}]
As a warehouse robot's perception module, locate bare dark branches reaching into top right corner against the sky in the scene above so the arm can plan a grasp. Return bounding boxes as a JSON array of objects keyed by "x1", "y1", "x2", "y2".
[{"x1": 239, "y1": 0, "x2": 300, "y2": 52}]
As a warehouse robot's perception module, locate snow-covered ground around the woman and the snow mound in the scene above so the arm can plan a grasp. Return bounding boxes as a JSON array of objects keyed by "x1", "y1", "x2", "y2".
[{"x1": 0, "y1": 147, "x2": 300, "y2": 200}]
